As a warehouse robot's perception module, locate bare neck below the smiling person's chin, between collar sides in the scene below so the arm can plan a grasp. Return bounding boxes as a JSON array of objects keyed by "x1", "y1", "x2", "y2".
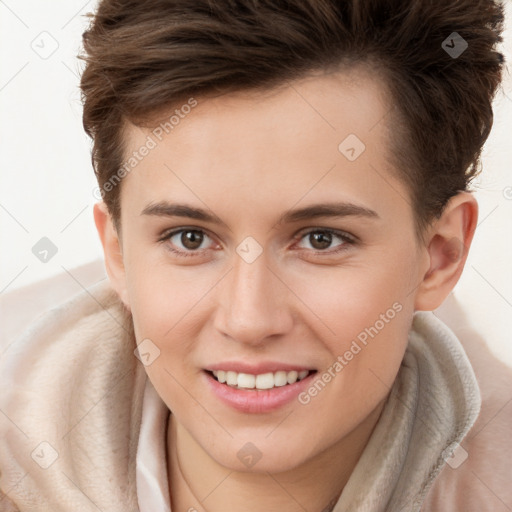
[{"x1": 167, "y1": 402, "x2": 384, "y2": 512}]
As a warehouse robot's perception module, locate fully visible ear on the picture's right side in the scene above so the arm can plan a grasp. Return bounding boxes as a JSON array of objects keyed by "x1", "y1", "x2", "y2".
[{"x1": 414, "y1": 192, "x2": 478, "y2": 311}]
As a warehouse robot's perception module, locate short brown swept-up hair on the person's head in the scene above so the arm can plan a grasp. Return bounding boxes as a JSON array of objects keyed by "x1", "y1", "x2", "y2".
[{"x1": 81, "y1": 0, "x2": 504, "y2": 240}]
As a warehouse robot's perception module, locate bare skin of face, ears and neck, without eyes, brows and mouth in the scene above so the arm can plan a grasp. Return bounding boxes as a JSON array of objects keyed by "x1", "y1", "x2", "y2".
[{"x1": 95, "y1": 71, "x2": 478, "y2": 512}]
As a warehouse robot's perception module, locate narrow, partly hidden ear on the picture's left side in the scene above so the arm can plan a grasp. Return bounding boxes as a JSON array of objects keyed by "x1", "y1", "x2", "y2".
[{"x1": 94, "y1": 202, "x2": 130, "y2": 310}]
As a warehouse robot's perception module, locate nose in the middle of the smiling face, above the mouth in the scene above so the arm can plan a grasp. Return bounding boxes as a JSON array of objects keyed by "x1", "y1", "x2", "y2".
[{"x1": 214, "y1": 249, "x2": 293, "y2": 346}]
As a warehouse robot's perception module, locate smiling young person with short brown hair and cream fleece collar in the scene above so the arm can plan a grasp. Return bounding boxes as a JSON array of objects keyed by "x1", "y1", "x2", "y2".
[{"x1": 0, "y1": 0, "x2": 510, "y2": 512}]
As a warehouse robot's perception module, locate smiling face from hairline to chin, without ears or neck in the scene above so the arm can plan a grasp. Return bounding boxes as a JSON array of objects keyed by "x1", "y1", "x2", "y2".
[{"x1": 112, "y1": 73, "x2": 426, "y2": 472}]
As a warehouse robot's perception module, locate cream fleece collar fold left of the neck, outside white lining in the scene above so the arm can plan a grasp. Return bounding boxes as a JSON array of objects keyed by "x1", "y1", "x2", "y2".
[{"x1": 0, "y1": 276, "x2": 146, "y2": 512}]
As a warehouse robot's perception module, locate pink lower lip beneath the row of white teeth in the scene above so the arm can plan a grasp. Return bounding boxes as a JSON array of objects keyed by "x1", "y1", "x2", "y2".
[{"x1": 203, "y1": 371, "x2": 316, "y2": 413}]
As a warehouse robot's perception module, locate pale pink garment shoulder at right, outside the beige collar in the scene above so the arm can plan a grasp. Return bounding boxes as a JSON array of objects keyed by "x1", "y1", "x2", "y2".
[{"x1": 422, "y1": 316, "x2": 512, "y2": 512}]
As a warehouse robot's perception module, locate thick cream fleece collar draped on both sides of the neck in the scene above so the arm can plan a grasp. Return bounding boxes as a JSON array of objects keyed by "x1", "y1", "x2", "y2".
[{"x1": 0, "y1": 282, "x2": 502, "y2": 512}]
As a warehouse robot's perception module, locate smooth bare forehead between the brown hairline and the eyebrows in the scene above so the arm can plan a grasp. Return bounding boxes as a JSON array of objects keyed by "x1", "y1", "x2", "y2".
[{"x1": 121, "y1": 68, "x2": 406, "y2": 226}]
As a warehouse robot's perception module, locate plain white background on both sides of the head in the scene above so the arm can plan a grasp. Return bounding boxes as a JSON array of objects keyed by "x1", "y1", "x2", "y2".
[{"x1": 0, "y1": 0, "x2": 512, "y2": 365}]
